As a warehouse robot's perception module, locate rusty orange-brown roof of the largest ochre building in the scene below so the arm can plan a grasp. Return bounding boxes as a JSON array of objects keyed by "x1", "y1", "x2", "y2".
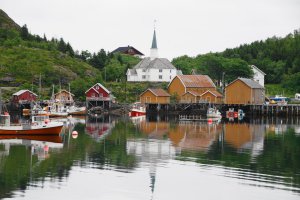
[{"x1": 176, "y1": 75, "x2": 216, "y2": 88}]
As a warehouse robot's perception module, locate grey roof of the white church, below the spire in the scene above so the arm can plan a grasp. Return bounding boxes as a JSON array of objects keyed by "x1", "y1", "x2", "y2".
[{"x1": 133, "y1": 57, "x2": 176, "y2": 69}]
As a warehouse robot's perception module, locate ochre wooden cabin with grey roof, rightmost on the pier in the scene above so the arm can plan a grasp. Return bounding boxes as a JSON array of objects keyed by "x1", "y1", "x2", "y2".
[{"x1": 225, "y1": 78, "x2": 265, "y2": 105}]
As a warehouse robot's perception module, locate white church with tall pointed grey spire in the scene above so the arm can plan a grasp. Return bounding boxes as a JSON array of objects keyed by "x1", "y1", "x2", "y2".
[{"x1": 126, "y1": 29, "x2": 182, "y2": 82}]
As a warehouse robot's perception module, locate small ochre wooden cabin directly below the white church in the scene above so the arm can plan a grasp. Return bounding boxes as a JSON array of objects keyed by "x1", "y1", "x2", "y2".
[{"x1": 140, "y1": 88, "x2": 171, "y2": 104}]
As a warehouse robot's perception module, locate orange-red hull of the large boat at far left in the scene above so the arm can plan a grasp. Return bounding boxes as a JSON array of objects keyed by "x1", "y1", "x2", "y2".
[{"x1": 0, "y1": 125, "x2": 63, "y2": 135}]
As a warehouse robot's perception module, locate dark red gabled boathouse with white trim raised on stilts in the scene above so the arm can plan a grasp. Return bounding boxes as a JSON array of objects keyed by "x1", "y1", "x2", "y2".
[{"x1": 85, "y1": 83, "x2": 114, "y2": 109}]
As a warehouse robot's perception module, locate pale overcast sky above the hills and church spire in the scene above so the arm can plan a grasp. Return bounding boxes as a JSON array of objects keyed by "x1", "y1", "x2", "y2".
[{"x1": 0, "y1": 0, "x2": 300, "y2": 60}]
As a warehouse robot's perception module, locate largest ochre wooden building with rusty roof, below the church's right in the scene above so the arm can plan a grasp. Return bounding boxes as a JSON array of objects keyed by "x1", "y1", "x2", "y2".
[{"x1": 168, "y1": 75, "x2": 216, "y2": 101}]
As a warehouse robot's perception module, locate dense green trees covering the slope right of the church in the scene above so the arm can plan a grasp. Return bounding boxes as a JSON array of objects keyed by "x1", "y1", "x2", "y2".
[{"x1": 172, "y1": 30, "x2": 300, "y2": 95}]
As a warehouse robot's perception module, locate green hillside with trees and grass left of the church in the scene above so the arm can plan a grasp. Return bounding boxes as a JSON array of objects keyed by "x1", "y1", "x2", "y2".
[{"x1": 0, "y1": 9, "x2": 140, "y2": 100}]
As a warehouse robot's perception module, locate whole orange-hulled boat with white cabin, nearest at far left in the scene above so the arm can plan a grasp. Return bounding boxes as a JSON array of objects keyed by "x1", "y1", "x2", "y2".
[{"x1": 0, "y1": 113, "x2": 63, "y2": 135}]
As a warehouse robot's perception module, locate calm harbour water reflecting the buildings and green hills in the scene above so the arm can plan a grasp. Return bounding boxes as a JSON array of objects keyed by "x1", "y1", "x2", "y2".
[{"x1": 0, "y1": 116, "x2": 300, "y2": 200}]
